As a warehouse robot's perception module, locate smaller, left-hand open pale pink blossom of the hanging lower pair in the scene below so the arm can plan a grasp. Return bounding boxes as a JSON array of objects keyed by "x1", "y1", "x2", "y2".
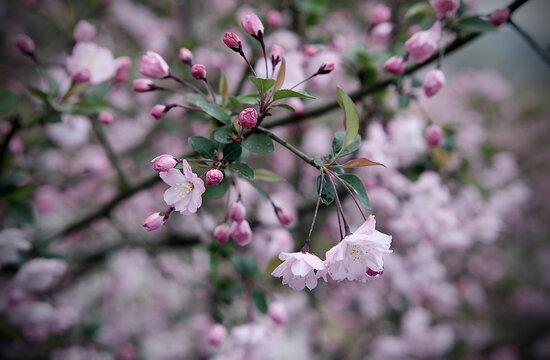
[{"x1": 271, "y1": 251, "x2": 326, "y2": 290}]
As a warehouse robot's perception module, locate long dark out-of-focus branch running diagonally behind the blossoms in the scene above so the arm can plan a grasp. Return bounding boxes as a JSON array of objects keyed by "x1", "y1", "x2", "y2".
[{"x1": 33, "y1": 0, "x2": 529, "y2": 243}]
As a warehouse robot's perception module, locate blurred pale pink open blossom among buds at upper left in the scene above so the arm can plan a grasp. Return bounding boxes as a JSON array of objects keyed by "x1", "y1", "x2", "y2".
[{"x1": 67, "y1": 41, "x2": 117, "y2": 85}]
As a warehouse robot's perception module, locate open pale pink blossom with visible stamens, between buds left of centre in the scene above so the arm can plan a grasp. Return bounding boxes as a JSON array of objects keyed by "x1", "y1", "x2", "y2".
[{"x1": 159, "y1": 165, "x2": 206, "y2": 215}]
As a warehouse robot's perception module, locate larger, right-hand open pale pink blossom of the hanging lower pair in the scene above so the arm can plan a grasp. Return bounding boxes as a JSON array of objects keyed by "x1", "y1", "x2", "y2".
[{"x1": 326, "y1": 215, "x2": 392, "y2": 282}]
